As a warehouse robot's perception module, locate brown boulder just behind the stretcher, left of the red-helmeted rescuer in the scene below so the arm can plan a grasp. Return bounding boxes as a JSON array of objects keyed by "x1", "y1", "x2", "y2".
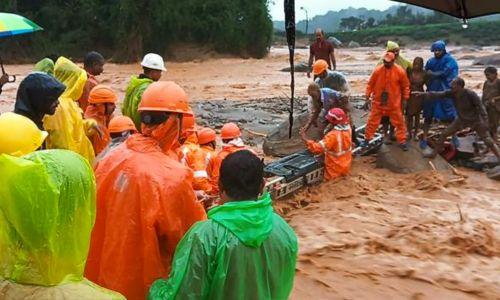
[{"x1": 262, "y1": 113, "x2": 321, "y2": 157}]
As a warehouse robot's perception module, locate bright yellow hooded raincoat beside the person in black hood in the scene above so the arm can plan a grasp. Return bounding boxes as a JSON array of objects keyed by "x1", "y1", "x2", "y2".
[{"x1": 43, "y1": 57, "x2": 95, "y2": 162}]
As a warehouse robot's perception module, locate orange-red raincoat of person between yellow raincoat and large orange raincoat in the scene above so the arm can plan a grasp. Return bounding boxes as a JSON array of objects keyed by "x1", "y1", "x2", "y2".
[{"x1": 85, "y1": 104, "x2": 113, "y2": 156}]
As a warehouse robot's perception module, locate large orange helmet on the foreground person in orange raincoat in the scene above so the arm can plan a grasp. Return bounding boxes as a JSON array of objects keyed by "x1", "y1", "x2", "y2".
[{"x1": 138, "y1": 81, "x2": 193, "y2": 115}]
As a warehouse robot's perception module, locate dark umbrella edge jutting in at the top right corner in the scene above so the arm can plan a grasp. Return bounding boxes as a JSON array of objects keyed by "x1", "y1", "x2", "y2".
[{"x1": 393, "y1": 0, "x2": 500, "y2": 24}]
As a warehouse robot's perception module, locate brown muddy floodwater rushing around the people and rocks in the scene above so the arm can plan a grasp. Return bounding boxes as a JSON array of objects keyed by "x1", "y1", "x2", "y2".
[{"x1": 0, "y1": 45, "x2": 500, "y2": 299}]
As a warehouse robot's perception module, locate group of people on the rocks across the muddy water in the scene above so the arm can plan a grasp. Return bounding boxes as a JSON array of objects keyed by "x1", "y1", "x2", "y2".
[{"x1": 304, "y1": 29, "x2": 500, "y2": 160}]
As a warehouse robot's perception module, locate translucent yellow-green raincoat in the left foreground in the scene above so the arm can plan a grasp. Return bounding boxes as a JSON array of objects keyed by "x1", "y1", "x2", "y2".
[{"x1": 0, "y1": 150, "x2": 123, "y2": 299}]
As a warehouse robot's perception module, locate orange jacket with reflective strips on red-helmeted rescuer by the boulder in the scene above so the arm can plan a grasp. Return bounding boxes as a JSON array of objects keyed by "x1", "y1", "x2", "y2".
[{"x1": 306, "y1": 125, "x2": 352, "y2": 180}]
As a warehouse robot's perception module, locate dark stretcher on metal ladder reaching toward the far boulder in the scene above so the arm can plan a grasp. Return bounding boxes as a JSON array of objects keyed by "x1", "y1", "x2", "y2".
[{"x1": 264, "y1": 126, "x2": 383, "y2": 200}]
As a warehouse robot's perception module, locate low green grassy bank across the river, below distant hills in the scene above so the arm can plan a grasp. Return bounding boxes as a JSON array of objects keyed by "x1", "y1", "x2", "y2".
[{"x1": 327, "y1": 21, "x2": 500, "y2": 46}]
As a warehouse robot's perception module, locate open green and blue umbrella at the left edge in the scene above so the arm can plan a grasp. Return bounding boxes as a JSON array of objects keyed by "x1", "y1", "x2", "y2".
[{"x1": 0, "y1": 13, "x2": 43, "y2": 82}]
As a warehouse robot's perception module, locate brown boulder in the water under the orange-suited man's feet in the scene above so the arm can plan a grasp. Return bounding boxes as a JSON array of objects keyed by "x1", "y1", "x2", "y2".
[{"x1": 376, "y1": 142, "x2": 451, "y2": 174}]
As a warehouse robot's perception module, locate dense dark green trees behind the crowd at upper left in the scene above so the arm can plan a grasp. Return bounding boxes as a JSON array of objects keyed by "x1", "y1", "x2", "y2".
[{"x1": 0, "y1": 0, "x2": 272, "y2": 62}]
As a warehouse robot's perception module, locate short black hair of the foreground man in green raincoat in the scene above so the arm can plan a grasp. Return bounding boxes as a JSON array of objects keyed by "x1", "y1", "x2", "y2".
[{"x1": 219, "y1": 150, "x2": 264, "y2": 201}]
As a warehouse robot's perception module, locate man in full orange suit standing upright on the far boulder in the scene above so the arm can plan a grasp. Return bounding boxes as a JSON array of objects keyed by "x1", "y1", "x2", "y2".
[{"x1": 364, "y1": 52, "x2": 410, "y2": 151}]
